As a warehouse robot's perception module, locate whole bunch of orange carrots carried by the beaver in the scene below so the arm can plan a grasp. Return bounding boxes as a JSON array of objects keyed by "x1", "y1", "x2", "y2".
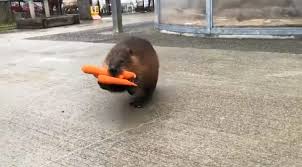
[{"x1": 82, "y1": 65, "x2": 137, "y2": 86}]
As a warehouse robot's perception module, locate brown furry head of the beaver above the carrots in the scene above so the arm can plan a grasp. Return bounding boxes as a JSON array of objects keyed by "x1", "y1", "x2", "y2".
[{"x1": 108, "y1": 48, "x2": 133, "y2": 76}]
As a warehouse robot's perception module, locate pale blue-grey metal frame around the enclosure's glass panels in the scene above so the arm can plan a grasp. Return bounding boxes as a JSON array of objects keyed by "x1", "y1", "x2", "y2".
[{"x1": 155, "y1": 0, "x2": 302, "y2": 36}]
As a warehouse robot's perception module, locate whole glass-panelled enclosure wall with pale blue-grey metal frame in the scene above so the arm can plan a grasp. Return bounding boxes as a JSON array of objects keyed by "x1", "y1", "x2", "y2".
[{"x1": 155, "y1": 0, "x2": 302, "y2": 36}]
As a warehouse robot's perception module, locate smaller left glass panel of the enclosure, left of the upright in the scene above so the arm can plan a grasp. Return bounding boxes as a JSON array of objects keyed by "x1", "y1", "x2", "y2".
[{"x1": 159, "y1": 0, "x2": 206, "y2": 26}]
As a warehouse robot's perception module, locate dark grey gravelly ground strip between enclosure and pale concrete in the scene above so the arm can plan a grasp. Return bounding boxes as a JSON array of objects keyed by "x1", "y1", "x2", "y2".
[{"x1": 27, "y1": 21, "x2": 302, "y2": 54}]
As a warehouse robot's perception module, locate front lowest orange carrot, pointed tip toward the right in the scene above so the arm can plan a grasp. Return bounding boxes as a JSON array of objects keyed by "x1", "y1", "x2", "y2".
[{"x1": 98, "y1": 75, "x2": 137, "y2": 86}]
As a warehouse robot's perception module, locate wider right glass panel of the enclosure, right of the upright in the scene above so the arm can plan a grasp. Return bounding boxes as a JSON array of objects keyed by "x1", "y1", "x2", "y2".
[{"x1": 213, "y1": 0, "x2": 302, "y2": 27}]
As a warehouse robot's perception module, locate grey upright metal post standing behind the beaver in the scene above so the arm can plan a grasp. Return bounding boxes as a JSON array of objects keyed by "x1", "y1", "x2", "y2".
[{"x1": 111, "y1": 0, "x2": 123, "y2": 33}]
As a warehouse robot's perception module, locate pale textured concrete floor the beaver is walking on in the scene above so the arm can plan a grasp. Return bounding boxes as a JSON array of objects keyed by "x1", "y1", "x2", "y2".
[{"x1": 0, "y1": 13, "x2": 302, "y2": 167}]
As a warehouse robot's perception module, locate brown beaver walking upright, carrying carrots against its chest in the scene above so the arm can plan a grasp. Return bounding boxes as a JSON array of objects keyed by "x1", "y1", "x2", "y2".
[{"x1": 99, "y1": 36, "x2": 159, "y2": 108}]
